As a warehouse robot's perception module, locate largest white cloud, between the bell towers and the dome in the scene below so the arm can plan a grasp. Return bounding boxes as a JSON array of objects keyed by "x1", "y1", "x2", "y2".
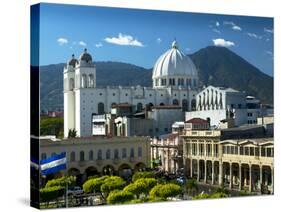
[{"x1": 104, "y1": 33, "x2": 144, "y2": 47}]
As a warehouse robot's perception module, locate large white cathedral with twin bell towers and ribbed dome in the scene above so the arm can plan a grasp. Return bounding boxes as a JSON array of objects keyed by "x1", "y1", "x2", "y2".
[{"x1": 63, "y1": 41, "x2": 198, "y2": 137}]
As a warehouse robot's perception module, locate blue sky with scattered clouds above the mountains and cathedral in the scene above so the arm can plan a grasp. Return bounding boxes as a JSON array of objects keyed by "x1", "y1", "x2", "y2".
[{"x1": 37, "y1": 4, "x2": 274, "y2": 76}]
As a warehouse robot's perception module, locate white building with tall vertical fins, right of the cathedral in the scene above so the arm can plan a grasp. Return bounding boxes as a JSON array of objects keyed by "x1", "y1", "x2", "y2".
[{"x1": 185, "y1": 86, "x2": 273, "y2": 128}]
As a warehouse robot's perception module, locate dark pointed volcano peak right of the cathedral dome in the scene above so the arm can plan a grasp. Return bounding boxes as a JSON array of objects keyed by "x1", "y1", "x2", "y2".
[{"x1": 190, "y1": 46, "x2": 273, "y2": 104}]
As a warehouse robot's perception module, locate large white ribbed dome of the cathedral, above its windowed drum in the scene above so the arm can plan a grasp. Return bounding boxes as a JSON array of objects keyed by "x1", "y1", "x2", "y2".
[{"x1": 152, "y1": 41, "x2": 197, "y2": 79}]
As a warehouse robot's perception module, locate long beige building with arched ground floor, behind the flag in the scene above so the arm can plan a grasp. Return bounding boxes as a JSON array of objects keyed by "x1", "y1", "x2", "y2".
[{"x1": 40, "y1": 137, "x2": 150, "y2": 181}]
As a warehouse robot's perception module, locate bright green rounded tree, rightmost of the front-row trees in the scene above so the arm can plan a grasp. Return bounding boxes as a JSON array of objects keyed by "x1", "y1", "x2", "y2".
[{"x1": 149, "y1": 183, "x2": 182, "y2": 200}]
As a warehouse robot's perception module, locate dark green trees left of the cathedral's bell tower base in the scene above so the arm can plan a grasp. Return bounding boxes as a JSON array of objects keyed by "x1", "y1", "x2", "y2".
[{"x1": 40, "y1": 117, "x2": 63, "y2": 137}]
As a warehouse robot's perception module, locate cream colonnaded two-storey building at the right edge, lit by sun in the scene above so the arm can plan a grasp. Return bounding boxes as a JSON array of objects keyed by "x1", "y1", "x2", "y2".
[{"x1": 182, "y1": 126, "x2": 274, "y2": 193}]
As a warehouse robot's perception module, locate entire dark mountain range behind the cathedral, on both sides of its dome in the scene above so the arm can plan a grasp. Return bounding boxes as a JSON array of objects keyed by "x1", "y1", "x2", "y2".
[{"x1": 40, "y1": 46, "x2": 273, "y2": 111}]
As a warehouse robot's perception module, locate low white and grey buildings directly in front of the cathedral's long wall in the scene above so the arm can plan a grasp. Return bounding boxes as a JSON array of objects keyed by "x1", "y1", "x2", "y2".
[{"x1": 92, "y1": 104, "x2": 184, "y2": 137}]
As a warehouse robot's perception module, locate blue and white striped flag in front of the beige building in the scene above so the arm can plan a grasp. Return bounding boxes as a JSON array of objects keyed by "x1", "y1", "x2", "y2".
[{"x1": 40, "y1": 152, "x2": 66, "y2": 175}]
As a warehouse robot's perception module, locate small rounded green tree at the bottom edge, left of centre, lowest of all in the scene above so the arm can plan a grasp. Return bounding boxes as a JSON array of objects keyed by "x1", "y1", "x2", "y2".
[{"x1": 106, "y1": 190, "x2": 134, "y2": 204}]
